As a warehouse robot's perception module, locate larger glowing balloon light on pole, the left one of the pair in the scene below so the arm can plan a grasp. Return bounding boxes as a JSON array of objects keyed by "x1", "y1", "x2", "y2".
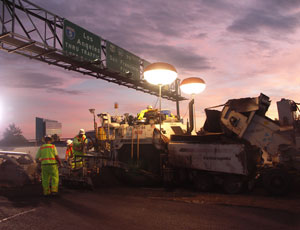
[{"x1": 144, "y1": 62, "x2": 177, "y2": 85}]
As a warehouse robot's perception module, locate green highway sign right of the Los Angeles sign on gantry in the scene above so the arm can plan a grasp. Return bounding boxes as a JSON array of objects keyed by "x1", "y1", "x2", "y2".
[{"x1": 106, "y1": 41, "x2": 141, "y2": 79}]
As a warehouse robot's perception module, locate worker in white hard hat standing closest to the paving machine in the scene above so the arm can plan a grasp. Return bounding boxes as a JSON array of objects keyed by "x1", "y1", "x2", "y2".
[{"x1": 73, "y1": 129, "x2": 88, "y2": 168}]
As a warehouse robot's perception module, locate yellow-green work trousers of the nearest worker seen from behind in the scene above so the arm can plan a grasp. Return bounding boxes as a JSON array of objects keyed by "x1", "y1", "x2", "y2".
[{"x1": 42, "y1": 164, "x2": 59, "y2": 195}]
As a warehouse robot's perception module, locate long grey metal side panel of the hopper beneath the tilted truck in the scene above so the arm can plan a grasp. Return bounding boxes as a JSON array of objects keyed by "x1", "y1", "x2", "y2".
[{"x1": 168, "y1": 143, "x2": 248, "y2": 175}]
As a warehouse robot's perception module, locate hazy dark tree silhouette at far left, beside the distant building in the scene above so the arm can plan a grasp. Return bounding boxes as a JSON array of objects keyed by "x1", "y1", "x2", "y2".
[{"x1": 0, "y1": 123, "x2": 28, "y2": 145}]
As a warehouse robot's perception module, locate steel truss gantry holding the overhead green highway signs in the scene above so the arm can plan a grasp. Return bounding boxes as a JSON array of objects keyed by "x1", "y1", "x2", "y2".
[{"x1": 0, "y1": 0, "x2": 185, "y2": 102}]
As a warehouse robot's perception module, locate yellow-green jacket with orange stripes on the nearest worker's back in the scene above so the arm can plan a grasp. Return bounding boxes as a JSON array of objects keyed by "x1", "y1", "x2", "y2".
[{"x1": 35, "y1": 144, "x2": 58, "y2": 165}]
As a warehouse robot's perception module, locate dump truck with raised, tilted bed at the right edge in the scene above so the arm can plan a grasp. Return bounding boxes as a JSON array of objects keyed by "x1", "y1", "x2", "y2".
[{"x1": 220, "y1": 94, "x2": 300, "y2": 194}]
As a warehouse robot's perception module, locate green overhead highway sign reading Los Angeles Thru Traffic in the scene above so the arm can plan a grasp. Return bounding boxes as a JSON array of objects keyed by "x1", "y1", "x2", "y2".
[{"x1": 63, "y1": 19, "x2": 101, "y2": 61}]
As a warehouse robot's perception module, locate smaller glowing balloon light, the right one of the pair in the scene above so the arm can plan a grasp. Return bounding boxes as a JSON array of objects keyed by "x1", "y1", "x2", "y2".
[{"x1": 180, "y1": 77, "x2": 206, "y2": 94}]
